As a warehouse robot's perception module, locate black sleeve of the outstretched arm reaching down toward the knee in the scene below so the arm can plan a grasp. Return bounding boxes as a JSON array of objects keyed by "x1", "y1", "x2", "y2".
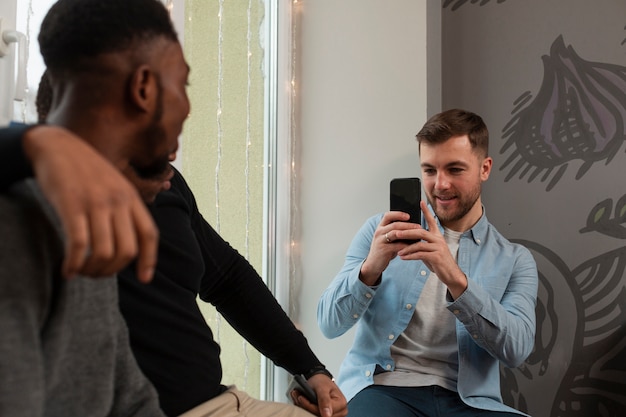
[{"x1": 173, "y1": 172, "x2": 321, "y2": 374}]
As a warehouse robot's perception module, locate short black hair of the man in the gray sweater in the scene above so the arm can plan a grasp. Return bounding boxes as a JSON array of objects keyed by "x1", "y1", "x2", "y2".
[{"x1": 38, "y1": 0, "x2": 178, "y2": 71}]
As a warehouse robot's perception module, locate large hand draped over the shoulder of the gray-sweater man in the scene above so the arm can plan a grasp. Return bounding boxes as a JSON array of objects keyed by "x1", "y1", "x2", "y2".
[{"x1": 22, "y1": 126, "x2": 158, "y2": 282}]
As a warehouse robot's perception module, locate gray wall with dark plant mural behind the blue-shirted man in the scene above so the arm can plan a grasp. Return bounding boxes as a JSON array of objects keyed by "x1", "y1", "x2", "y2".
[{"x1": 442, "y1": 0, "x2": 626, "y2": 417}]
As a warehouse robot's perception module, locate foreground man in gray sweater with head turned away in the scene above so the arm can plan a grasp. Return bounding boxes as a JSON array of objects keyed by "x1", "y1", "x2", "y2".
[{"x1": 0, "y1": 0, "x2": 189, "y2": 417}]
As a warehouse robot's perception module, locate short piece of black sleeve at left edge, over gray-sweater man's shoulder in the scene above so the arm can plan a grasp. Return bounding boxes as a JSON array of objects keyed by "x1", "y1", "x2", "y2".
[{"x1": 0, "y1": 124, "x2": 33, "y2": 191}]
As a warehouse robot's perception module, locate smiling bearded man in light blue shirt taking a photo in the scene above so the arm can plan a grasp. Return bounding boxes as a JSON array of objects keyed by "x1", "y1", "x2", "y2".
[{"x1": 318, "y1": 109, "x2": 538, "y2": 417}]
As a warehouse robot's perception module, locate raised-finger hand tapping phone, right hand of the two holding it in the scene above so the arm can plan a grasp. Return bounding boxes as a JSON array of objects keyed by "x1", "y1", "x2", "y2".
[{"x1": 397, "y1": 201, "x2": 467, "y2": 300}]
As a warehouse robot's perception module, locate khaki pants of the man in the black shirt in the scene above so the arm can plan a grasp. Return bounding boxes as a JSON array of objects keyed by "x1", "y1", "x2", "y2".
[{"x1": 179, "y1": 386, "x2": 313, "y2": 417}]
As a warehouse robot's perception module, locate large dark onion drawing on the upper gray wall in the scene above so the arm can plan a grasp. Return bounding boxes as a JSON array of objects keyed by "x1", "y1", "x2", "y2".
[{"x1": 500, "y1": 36, "x2": 626, "y2": 190}]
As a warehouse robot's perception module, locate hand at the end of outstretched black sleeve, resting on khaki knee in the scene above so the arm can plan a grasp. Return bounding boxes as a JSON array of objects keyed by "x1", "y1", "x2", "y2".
[{"x1": 291, "y1": 374, "x2": 348, "y2": 417}]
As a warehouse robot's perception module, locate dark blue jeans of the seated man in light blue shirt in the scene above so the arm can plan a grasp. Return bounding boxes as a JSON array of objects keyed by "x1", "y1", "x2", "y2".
[{"x1": 348, "y1": 385, "x2": 521, "y2": 417}]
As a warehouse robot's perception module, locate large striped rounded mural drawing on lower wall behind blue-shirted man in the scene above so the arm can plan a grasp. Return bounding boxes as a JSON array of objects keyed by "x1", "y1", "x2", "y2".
[{"x1": 501, "y1": 241, "x2": 626, "y2": 417}]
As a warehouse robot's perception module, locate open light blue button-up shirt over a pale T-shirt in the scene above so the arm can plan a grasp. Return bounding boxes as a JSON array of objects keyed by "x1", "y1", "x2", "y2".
[{"x1": 317, "y1": 206, "x2": 538, "y2": 414}]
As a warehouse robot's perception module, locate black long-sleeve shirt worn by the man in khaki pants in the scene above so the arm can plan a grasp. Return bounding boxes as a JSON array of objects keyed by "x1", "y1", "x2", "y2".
[{"x1": 0, "y1": 125, "x2": 321, "y2": 415}]
